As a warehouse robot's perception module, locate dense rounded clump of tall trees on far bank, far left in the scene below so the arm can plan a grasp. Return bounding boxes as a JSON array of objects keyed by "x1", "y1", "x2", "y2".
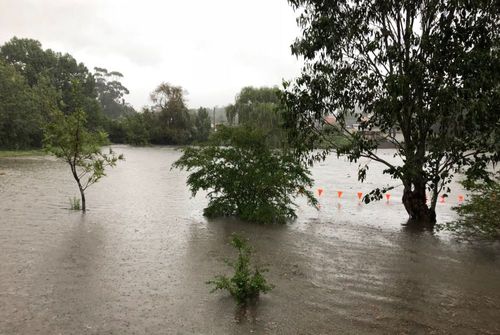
[{"x1": 0, "y1": 37, "x2": 110, "y2": 149}]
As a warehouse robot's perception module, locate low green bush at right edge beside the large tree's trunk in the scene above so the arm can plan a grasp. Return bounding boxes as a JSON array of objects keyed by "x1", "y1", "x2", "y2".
[{"x1": 438, "y1": 180, "x2": 500, "y2": 240}]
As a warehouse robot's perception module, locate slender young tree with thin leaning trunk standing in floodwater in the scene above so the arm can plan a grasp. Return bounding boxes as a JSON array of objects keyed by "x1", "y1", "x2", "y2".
[{"x1": 44, "y1": 110, "x2": 123, "y2": 211}]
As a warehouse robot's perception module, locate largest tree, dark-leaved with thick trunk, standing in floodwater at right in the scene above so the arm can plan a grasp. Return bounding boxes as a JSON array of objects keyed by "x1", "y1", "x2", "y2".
[{"x1": 283, "y1": 0, "x2": 500, "y2": 226}]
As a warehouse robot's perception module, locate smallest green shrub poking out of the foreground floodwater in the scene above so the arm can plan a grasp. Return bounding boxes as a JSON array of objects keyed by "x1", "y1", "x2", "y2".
[{"x1": 207, "y1": 234, "x2": 274, "y2": 305}]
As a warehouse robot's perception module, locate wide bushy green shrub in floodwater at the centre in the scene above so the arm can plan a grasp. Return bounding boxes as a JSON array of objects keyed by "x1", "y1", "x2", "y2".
[{"x1": 173, "y1": 126, "x2": 317, "y2": 223}]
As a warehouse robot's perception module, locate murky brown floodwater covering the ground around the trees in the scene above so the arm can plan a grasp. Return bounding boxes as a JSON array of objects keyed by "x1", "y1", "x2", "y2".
[{"x1": 0, "y1": 146, "x2": 500, "y2": 335}]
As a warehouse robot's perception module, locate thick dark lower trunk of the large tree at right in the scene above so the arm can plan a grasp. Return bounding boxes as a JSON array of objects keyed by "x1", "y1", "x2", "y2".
[{"x1": 403, "y1": 183, "x2": 436, "y2": 228}]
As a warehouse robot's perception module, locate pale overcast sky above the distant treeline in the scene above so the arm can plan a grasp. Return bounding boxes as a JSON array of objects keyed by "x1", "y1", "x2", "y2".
[{"x1": 0, "y1": 0, "x2": 300, "y2": 108}]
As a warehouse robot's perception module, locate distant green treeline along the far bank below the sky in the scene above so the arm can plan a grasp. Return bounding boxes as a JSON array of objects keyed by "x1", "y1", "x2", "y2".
[{"x1": 0, "y1": 37, "x2": 288, "y2": 149}]
